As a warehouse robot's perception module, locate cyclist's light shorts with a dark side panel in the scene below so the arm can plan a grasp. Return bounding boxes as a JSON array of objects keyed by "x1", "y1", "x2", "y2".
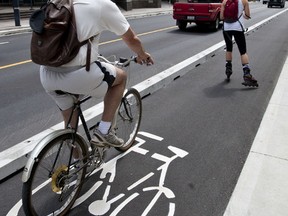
[{"x1": 40, "y1": 62, "x2": 116, "y2": 110}]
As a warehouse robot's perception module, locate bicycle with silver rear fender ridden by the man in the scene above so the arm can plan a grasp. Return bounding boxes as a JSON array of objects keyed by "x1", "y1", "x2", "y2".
[{"x1": 22, "y1": 56, "x2": 142, "y2": 216}]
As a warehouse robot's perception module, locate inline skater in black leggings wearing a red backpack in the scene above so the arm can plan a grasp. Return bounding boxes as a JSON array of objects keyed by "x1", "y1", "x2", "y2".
[{"x1": 220, "y1": 0, "x2": 258, "y2": 86}]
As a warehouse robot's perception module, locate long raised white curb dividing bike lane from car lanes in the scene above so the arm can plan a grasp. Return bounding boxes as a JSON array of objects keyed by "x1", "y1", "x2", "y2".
[{"x1": 0, "y1": 8, "x2": 288, "y2": 180}]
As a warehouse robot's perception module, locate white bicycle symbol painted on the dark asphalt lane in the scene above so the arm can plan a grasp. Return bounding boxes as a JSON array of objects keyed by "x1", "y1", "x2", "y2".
[{"x1": 7, "y1": 132, "x2": 188, "y2": 216}]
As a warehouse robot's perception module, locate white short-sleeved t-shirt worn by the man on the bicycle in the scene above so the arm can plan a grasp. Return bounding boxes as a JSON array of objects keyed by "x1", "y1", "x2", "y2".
[{"x1": 63, "y1": 0, "x2": 130, "y2": 67}]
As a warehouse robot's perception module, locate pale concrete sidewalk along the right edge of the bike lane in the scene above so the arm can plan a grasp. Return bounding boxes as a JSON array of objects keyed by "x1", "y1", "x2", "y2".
[{"x1": 224, "y1": 57, "x2": 288, "y2": 216}]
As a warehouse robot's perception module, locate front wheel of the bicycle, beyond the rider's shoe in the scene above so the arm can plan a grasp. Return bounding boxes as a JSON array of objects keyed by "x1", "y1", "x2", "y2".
[{"x1": 116, "y1": 88, "x2": 142, "y2": 152}]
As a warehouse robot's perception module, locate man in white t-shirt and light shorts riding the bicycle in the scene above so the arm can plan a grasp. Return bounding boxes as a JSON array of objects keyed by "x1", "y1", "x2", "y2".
[{"x1": 40, "y1": 0, "x2": 154, "y2": 147}]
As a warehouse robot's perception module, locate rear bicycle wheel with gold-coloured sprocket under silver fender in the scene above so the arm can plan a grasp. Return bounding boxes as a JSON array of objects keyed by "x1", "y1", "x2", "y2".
[{"x1": 22, "y1": 133, "x2": 87, "y2": 216}]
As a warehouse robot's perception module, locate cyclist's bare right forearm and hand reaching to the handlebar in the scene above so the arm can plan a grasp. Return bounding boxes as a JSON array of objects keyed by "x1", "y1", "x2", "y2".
[{"x1": 122, "y1": 27, "x2": 154, "y2": 64}]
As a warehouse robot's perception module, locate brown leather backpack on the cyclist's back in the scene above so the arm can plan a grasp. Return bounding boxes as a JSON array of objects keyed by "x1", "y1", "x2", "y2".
[{"x1": 30, "y1": 0, "x2": 94, "y2": 71}]
